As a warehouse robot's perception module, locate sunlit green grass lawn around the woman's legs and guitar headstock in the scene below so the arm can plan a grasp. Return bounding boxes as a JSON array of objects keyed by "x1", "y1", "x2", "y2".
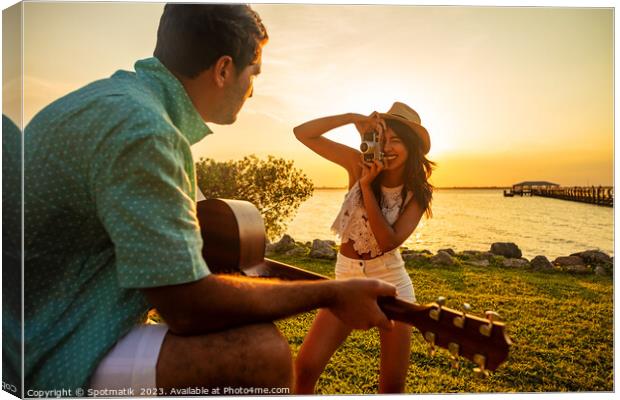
[{"x1": 273, "y1": 256, "x2": 614, "y2": 394}]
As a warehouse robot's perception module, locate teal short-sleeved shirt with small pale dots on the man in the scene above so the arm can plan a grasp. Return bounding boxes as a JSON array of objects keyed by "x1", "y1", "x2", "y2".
[{"x1": 16, "y1": 58, "x2": 211, "y2": 390}]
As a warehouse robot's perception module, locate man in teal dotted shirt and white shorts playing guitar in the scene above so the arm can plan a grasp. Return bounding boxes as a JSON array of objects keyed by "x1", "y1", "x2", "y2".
[{"x1": 8, "y1": 4, "x2": 395, "y2": 396}]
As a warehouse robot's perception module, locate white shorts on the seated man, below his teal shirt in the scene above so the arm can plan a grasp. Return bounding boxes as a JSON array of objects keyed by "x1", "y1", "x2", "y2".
[{"x1": 90, "y1": 324, "x2": 168, "y2": 397}]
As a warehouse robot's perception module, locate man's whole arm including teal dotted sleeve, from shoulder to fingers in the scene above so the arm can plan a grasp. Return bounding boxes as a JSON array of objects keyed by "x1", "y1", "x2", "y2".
[{"x1": 91, "y1": 128, "x2": 395, "y2": 334}]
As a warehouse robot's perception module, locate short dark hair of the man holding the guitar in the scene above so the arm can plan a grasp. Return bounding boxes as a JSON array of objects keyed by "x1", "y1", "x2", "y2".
[{"x1": 153, "y1": 4, "x2": 268, "y2": 78}]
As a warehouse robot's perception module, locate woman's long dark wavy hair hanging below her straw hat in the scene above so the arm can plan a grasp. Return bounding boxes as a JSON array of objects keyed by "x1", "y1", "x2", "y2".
[{"x1": 372, "y1": 119, "x2": 436, "y2": 218}]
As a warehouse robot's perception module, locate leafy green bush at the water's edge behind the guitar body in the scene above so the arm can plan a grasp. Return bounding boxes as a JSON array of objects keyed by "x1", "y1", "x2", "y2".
[{"x1": 196, "y1": 155, "x2": 314, "y2": 240}]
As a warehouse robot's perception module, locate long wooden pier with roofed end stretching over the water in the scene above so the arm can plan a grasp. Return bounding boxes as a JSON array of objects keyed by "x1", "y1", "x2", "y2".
[{"x1": 504, "y1": 181, "x2": 614, "y2": 207}]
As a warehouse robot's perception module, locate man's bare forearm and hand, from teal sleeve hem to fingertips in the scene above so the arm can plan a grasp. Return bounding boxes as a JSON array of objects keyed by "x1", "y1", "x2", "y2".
[{"x1": 143, "y1": 275, "x2": 396, "y2": 335}]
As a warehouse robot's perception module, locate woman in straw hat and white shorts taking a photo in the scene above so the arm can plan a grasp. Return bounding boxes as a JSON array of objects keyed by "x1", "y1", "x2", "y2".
[{"x1": 294, "y1": 102, "x2": 434, "y2": 394}]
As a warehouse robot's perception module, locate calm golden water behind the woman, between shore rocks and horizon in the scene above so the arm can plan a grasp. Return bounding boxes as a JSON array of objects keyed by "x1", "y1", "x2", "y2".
[{"x1": 287, "y1": 190, "x2": 614, "y2": 259}]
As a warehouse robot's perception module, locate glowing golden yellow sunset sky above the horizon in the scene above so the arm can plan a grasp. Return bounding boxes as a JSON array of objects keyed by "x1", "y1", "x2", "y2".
[{"x1": 4, "y1": 3, "x2": 614, "y2": 186}]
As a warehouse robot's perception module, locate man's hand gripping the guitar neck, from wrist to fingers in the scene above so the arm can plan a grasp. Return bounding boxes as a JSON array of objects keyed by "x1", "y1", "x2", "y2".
[{"x1": 329, "y1": 278, "x2": 396, "y2": 329}]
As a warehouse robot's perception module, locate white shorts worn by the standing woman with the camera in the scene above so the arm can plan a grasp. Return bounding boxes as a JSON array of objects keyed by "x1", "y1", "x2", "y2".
[{"x1": 336, "y1": 250, "x2": 415, "y2": 303}]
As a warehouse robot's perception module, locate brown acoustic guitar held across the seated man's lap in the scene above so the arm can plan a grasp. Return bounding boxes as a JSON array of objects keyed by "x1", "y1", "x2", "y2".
[{"x1": 197, "y1": 199, "x2": 512, "y2": 374}]
